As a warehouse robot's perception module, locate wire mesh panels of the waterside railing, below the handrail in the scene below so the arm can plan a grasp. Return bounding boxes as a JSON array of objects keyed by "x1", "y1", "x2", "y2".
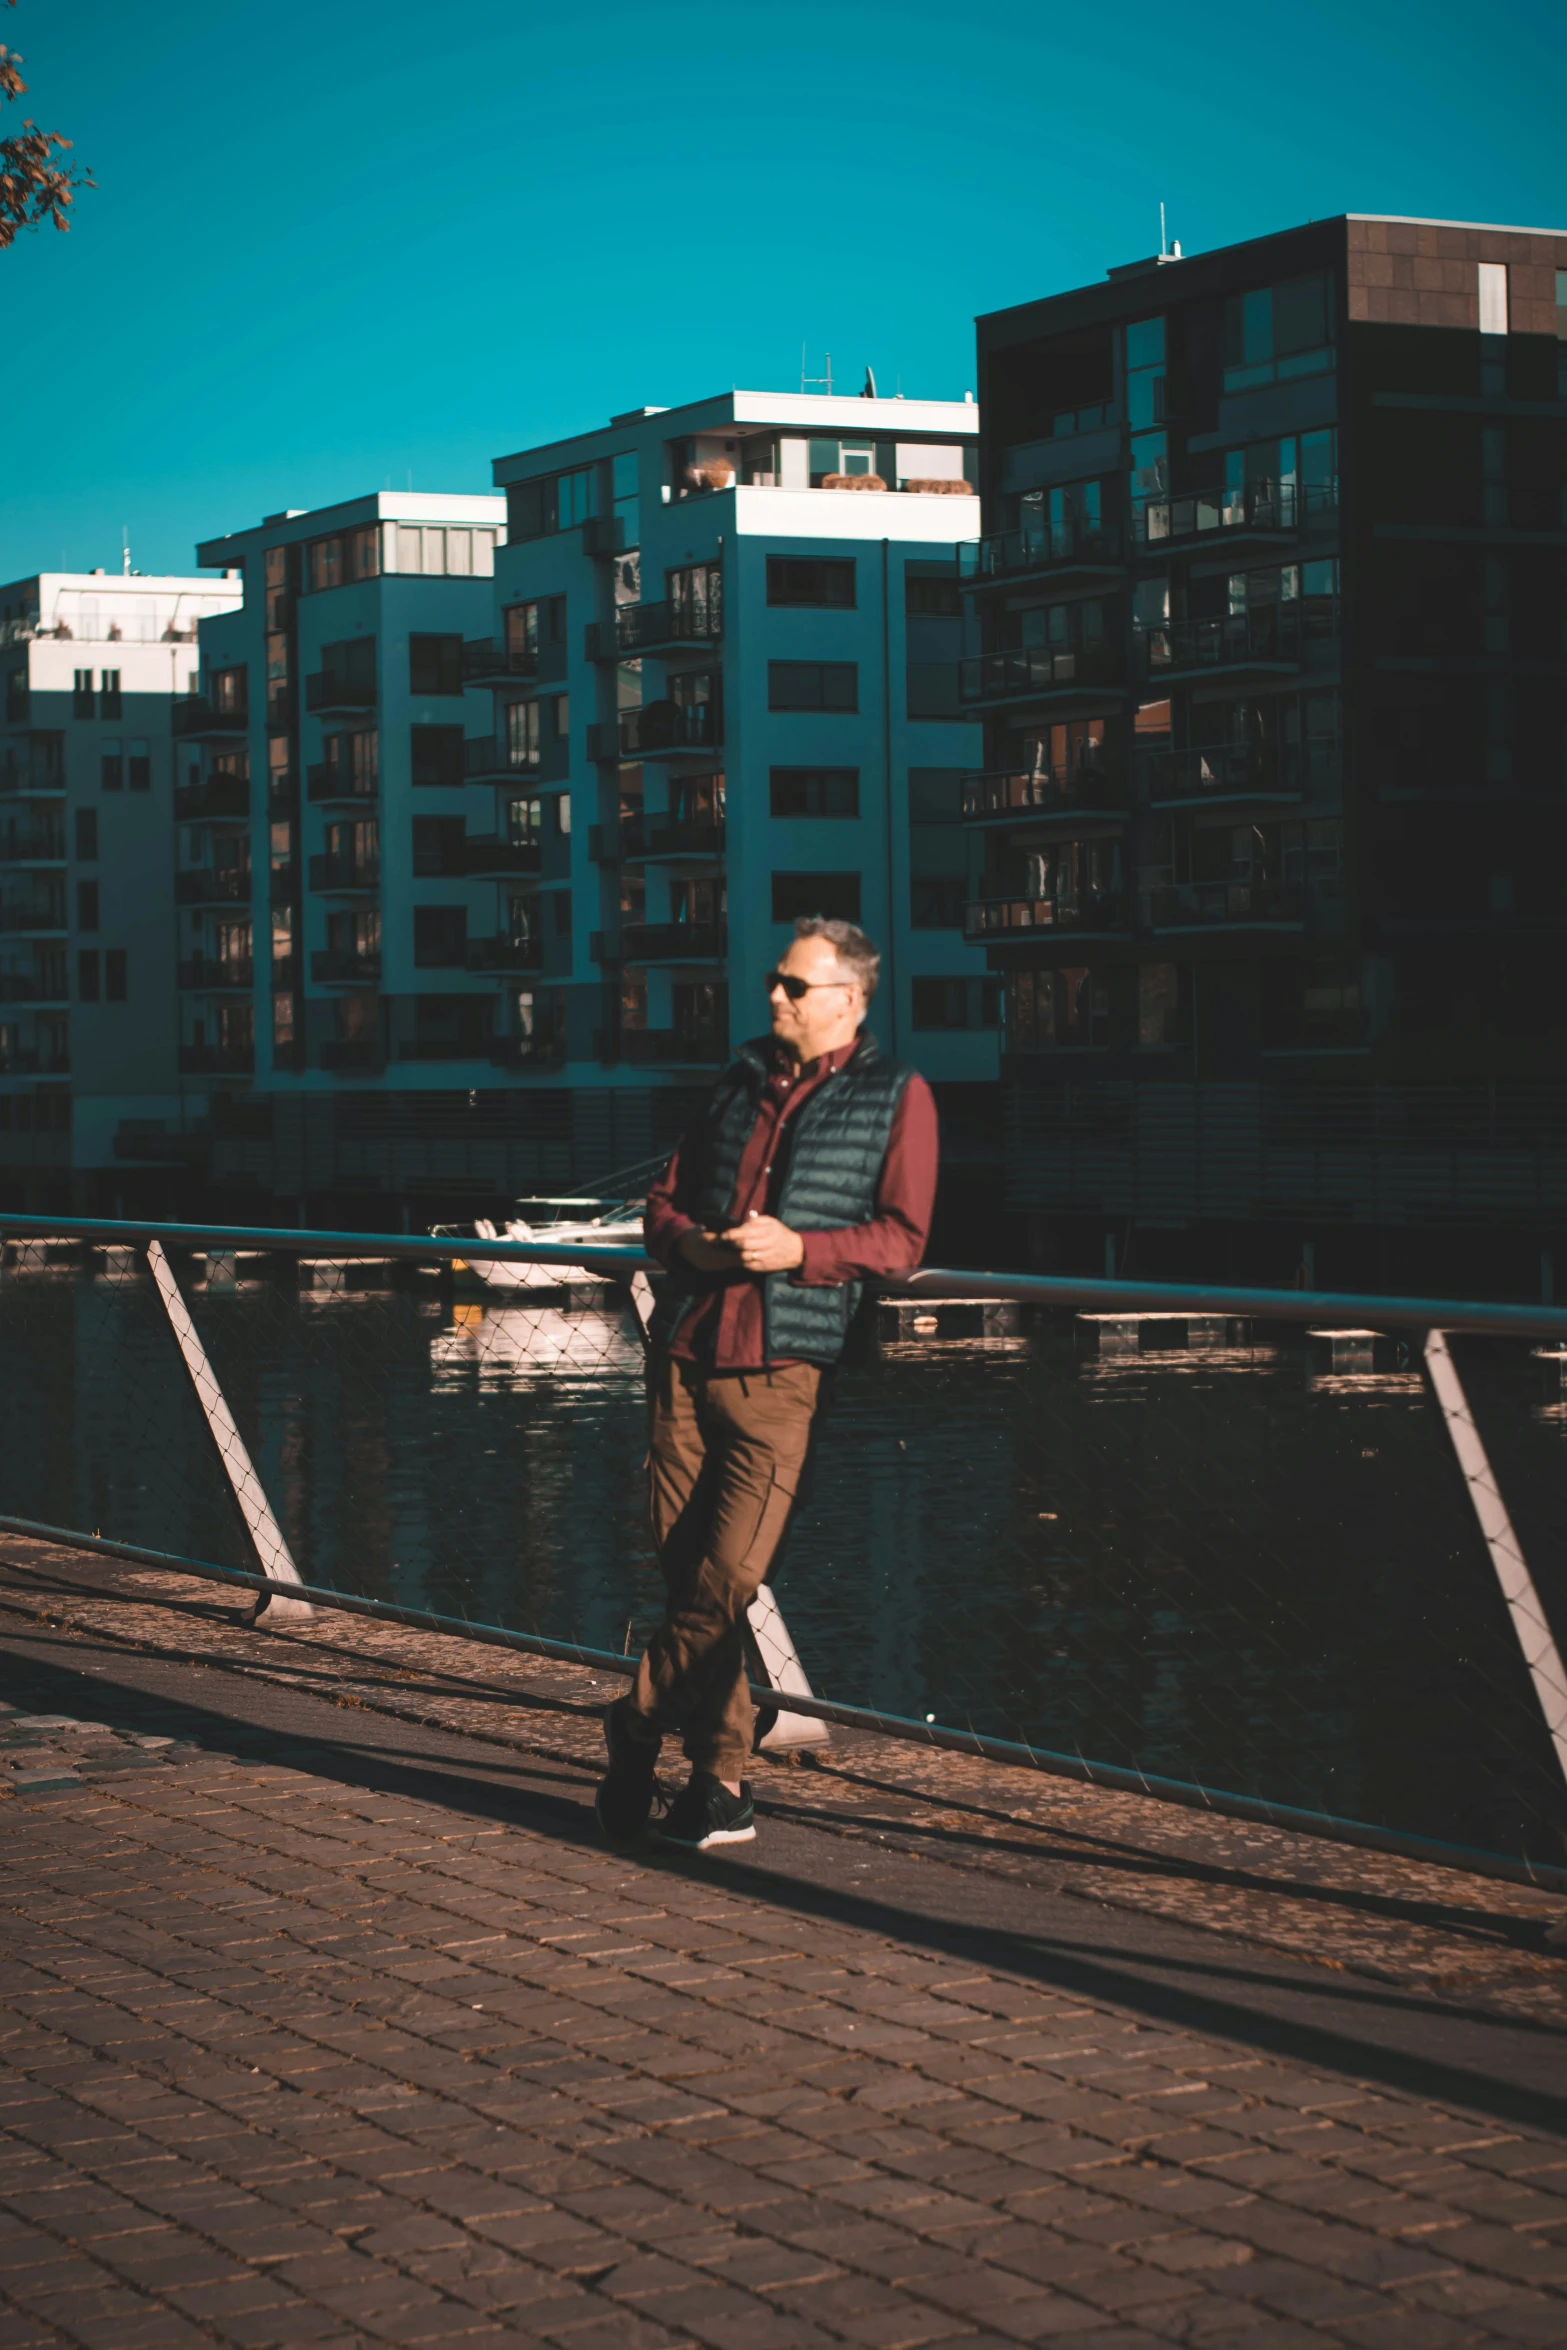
[{"x1": 0, "y1": 1227, "x2": 1567, "y2": 1866}]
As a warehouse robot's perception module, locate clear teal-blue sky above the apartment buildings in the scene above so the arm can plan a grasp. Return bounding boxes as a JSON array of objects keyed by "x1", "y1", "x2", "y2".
[{"x1": 0, "y1": 0, "x2": 1567, "y2": 580}]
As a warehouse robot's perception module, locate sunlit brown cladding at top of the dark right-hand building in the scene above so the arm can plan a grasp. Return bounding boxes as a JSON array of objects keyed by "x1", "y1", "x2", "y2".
[{"x1": 1346, "y1": 219, "x2": 1567, "y2": 334}]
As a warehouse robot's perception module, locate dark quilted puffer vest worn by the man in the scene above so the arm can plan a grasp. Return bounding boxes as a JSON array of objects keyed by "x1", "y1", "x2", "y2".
[{"x1": 653, "y1": 1029, "x2": 909, "y2": 1363}]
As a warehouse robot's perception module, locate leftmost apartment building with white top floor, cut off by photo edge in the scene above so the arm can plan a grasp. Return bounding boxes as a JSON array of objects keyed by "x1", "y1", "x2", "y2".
[{"x1": 0, "y1": 571, "x2": 240, "y2": 1210}]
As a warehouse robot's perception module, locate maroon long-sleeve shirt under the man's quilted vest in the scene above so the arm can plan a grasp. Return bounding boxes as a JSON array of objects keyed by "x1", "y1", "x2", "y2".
[{"x1": 644, "y1": 1043, "x2": 937, "y2": 1372}]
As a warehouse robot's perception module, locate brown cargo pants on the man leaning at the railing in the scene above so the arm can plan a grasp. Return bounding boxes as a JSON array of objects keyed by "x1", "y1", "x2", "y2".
[{"x1": 632, "y1": 1356, "x2": 822, "y2": 1779}]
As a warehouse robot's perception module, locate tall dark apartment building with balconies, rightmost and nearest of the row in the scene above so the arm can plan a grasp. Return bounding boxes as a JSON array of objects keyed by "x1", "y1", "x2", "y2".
[{"x1": 959, "y1": 216, "x2": 1567, "y2": 1293}]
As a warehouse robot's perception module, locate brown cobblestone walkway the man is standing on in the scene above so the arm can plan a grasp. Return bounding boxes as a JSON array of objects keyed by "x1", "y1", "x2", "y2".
[{"x1": 0, "y1": 1544, "x2": 1567, "y2": 2350}]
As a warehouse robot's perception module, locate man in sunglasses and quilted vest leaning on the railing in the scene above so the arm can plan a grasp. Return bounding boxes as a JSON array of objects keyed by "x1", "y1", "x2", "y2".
[{"x1": 597, "y1": 919, "x2": 937, "y2": 1852}]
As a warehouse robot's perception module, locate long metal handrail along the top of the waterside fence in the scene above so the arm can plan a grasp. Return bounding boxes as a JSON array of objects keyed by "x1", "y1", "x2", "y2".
[{"x1": 0, "y1": 1213, "x2": 1567, "y2": 1340}]
